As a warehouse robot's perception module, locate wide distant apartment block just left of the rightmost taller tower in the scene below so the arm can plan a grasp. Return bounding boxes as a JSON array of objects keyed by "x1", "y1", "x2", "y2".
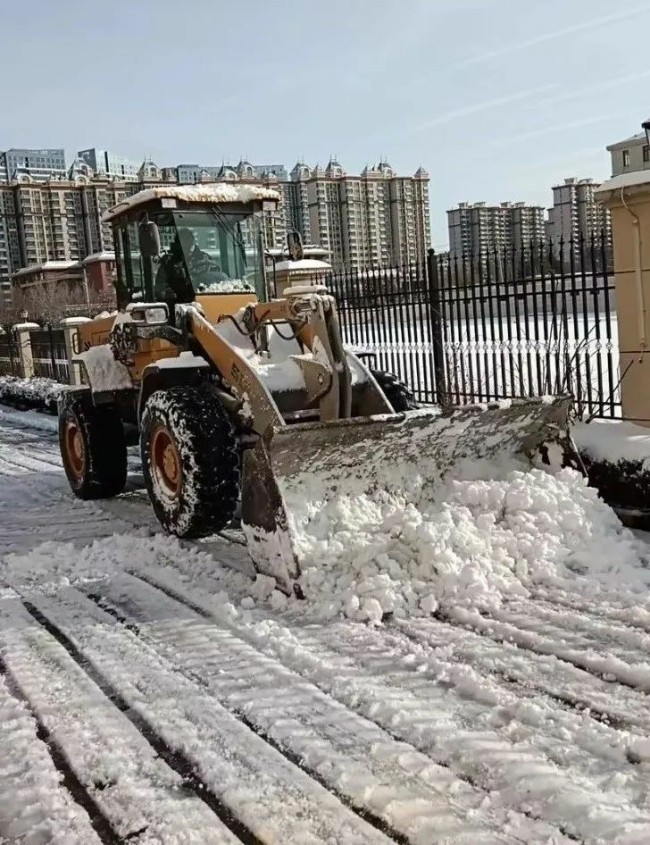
[{"x1": 447, "y1": 202, "x2": 544, "y2": 256}]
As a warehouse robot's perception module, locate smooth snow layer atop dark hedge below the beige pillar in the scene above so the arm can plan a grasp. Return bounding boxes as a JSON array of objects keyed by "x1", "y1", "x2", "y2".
[{"x1": 572, "y1": 420, "x2": 650, "y2": 470}]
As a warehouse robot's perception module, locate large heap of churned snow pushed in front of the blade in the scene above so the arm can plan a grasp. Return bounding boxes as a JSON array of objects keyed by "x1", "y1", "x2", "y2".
[{"x1": 285, "y1": 469, "x2": 650, "y2": 623}]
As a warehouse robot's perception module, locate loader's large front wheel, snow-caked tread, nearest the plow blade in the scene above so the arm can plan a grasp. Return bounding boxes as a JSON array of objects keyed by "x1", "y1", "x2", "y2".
[{"x1": 140, "y1": 387, "x2": 241, "y2": 537}]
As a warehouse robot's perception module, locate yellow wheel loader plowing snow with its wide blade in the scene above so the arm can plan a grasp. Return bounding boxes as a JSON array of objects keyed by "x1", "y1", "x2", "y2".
[{"x1": 59, "y1": 183, "x2": 570, "y2": 593}]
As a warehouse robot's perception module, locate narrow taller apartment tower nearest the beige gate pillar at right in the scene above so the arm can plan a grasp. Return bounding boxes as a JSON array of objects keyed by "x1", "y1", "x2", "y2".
[{"x1": 547, "y1": 177, "x2": 611, "y2": 246}]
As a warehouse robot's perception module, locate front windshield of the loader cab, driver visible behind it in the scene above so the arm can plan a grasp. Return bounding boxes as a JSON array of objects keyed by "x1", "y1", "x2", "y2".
[{"x1": 152, "y1": 208, "x2": 264, "y2": 302}]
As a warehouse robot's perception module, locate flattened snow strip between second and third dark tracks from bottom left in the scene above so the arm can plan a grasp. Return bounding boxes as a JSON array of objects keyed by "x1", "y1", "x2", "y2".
[{"x1": 23, "y1": 589, "x2": 402, "y2": 845}]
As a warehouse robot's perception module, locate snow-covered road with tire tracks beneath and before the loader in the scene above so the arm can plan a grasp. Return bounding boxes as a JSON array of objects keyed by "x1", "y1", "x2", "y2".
[{"x1": 0, "y1": 409, "x2": 650, "y2": 845}]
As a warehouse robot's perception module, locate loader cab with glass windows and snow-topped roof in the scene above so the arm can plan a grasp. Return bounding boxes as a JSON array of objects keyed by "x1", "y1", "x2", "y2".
[{"x1": 107, "y1": 184, "x2": 277, "y2": 319}]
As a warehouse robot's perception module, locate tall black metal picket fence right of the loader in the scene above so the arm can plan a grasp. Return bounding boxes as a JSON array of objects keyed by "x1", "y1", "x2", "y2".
[{"x1": 327, "y1": 232, "x2": 621, "y2": 417}]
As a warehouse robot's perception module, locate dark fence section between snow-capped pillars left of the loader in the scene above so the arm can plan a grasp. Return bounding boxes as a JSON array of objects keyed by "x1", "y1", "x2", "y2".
[{"x1": 0, "y1": 317, "x2": 86, "y2": 384}]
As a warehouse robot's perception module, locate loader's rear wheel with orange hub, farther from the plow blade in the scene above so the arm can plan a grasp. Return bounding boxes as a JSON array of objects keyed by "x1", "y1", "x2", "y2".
[{"x1": 59, "y1": 393, "x2": 127, "y2": 499}]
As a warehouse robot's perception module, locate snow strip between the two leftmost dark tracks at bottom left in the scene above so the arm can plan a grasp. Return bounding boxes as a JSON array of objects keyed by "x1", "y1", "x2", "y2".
[{"x1": 0, "y1": 599, "x2": 240, "y2": 845}]
